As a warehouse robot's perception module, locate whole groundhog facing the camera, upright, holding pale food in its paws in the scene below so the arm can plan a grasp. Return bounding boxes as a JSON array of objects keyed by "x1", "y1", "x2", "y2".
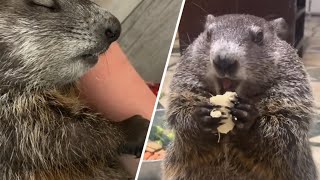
[{"x1": 163, "y1": 14, "x2": 317, "y2": 180}]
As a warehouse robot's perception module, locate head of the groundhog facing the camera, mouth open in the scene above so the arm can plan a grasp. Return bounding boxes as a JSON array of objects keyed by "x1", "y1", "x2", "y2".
[{"x1": 202, "y1": 15, "x2": 286, "y2": 97}]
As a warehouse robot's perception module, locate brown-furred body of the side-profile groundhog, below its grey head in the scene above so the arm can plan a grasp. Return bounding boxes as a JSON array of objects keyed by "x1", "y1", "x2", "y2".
[{"x1": 0, "y1": 86, "x2": 130, "y2": 179}]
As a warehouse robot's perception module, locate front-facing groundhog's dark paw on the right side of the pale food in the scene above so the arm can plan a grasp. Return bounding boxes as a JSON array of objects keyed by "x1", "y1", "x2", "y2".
[{"x1": 231, "y1": 98, "x2": 259, "y2": 130}]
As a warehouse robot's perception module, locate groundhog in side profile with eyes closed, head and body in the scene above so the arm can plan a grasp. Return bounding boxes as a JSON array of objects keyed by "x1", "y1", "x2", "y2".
[{"x1": 0, "y1": 0, "x2": 148, "y2": 180}]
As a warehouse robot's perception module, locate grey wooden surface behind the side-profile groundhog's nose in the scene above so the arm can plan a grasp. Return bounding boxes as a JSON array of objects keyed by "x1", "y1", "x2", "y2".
[{"x1": 94, "y1": 0, "x2": 183, "y2": 82}]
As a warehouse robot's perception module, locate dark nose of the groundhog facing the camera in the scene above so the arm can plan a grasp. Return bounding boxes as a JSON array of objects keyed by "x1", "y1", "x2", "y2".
[{"x1": 213, "y1": 56, "x2": 239, "y2": 75}]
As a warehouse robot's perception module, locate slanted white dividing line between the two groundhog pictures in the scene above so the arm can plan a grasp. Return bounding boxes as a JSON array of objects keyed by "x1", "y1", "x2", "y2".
[{"x1": 135, "y1": 0, "x2": 186, "y2": 180}]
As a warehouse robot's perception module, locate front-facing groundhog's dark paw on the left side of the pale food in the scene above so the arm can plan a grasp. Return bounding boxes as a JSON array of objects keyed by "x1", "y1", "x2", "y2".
[{"x1": 193, "y1": 102, "x2": 224, "y2": 135}]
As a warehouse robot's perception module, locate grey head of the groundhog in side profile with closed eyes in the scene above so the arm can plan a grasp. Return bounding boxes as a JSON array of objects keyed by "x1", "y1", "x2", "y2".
[{"x1": 0, "y1": 0, "x2": 121, "y2": 86}]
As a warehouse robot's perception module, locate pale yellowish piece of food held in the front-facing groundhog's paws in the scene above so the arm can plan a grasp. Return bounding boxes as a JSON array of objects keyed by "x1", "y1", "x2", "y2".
[{"x1": 210, "y1": 91, "x2": 237, "y2": 134}]
